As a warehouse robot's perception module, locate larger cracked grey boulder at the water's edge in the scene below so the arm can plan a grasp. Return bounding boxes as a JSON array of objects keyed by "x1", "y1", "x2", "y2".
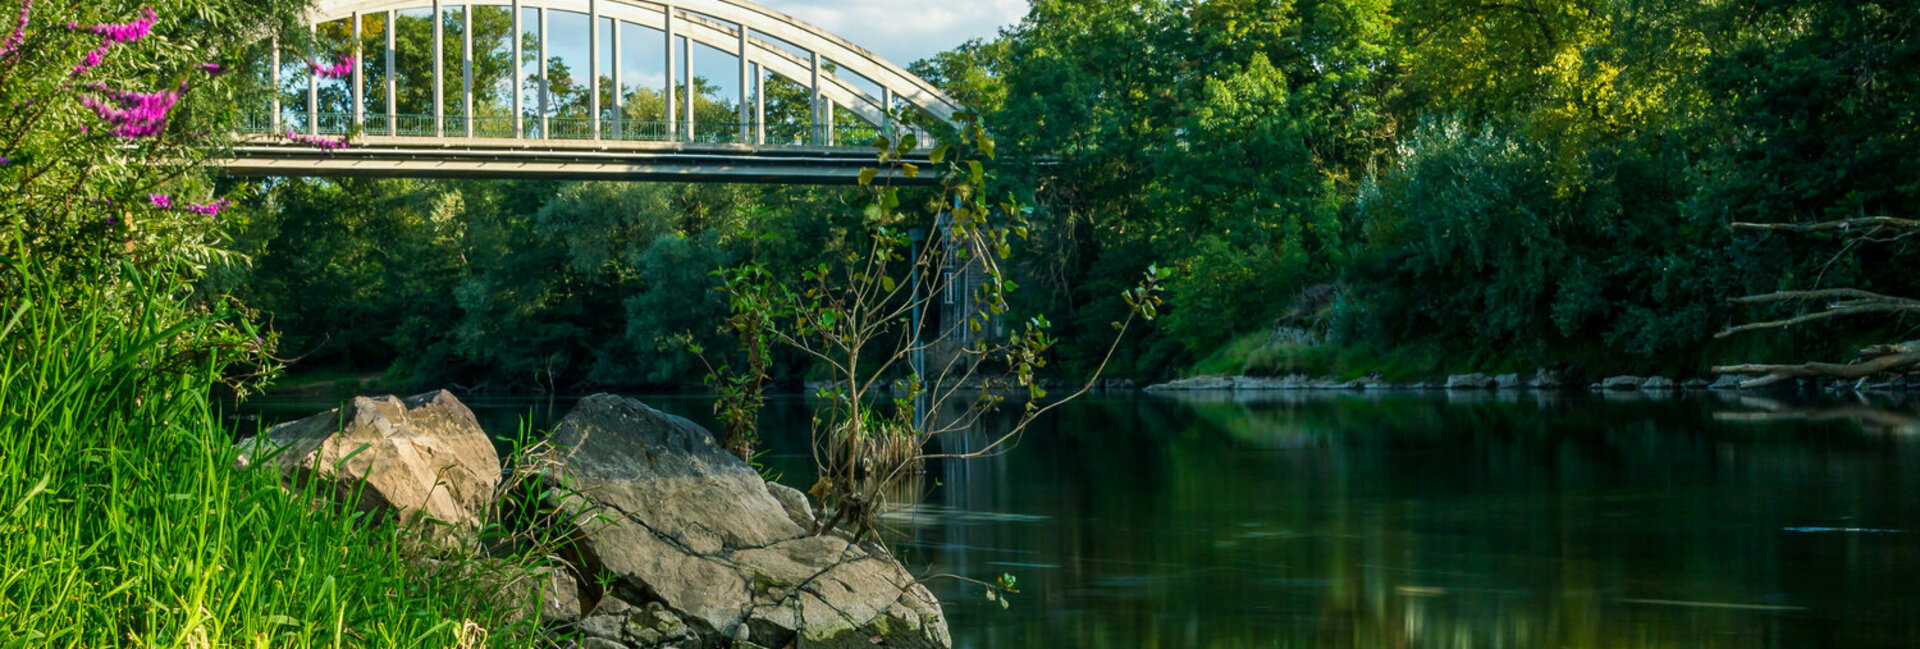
[{"x1": 541, "y1": 396, "x2": 950, "y2": 649}]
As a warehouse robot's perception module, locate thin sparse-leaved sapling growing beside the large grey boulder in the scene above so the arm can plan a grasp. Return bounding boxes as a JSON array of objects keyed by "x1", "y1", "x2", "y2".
[{"x1": 722, "y1": 123, "x2": 1160, "y2": 541}]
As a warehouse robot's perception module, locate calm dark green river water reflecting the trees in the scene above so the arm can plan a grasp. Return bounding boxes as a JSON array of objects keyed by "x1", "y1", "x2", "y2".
[{"x1": 236, "y1": 387, "x2": 1920, "y2": 647}]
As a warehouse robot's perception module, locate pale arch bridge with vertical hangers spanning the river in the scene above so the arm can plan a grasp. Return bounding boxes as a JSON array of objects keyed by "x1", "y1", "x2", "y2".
[{"x1": 223, "y1": 0, "x2": 960, "y2": 184}]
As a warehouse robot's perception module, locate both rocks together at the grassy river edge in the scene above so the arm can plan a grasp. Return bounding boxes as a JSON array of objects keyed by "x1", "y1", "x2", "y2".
[{"x1": 244, "y1": 392, "x2": 950, "y2": 649}]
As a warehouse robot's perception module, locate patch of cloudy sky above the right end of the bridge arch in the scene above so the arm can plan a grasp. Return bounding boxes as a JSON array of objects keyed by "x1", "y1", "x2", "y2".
[{"x1": 758, "y1": 0, "x2": 1027, "y2": 65}]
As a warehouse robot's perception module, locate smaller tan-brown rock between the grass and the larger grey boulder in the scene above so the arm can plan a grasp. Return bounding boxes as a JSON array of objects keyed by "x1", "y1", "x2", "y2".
[{"x1": 240, "y1": 390, "x2": 501, "y2": 526}]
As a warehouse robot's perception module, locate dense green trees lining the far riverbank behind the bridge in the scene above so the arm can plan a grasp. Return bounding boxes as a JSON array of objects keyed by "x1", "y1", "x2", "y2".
[{"x1": 236, "y1": 0, "x2": 1920, "y2": 384}]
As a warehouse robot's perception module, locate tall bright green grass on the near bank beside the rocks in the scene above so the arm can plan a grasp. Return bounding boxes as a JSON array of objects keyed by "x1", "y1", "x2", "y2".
[{"x1": 0, "y1": 263, "x2": 549, "y2": 649}]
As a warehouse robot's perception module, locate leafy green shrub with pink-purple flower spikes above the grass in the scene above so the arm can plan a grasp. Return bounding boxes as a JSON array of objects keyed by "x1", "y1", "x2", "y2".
[{"x1": 0, "y1": 0, "x2": 288, "y2": 290}]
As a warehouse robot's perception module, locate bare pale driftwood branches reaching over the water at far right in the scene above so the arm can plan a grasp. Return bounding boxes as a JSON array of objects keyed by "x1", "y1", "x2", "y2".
[{"x1": 1713, "y1": 217, "x2": 1920, "y2": 388}]
